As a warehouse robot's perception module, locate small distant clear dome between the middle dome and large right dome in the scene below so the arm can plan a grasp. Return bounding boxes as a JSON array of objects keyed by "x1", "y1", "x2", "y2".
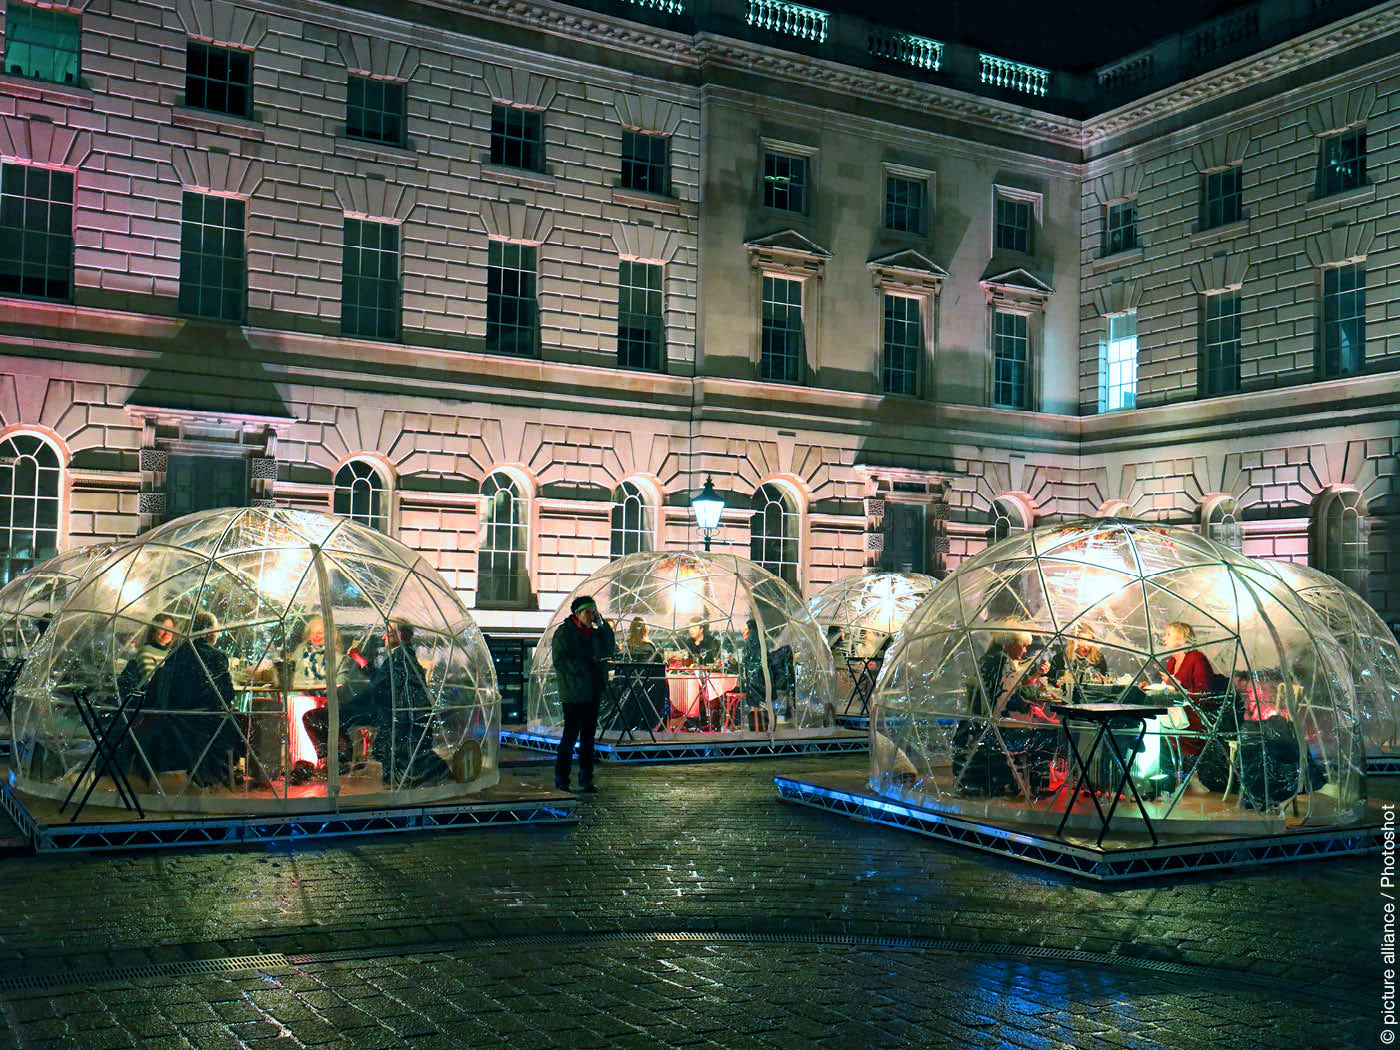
[{"x1": 806, "y1": 571, "x2": 938, "y2": 714}]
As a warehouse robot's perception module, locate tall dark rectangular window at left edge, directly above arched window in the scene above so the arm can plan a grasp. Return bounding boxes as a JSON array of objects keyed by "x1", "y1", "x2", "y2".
[{"x1": 0, "y1": 164, "x2": 73, "y2": 301}]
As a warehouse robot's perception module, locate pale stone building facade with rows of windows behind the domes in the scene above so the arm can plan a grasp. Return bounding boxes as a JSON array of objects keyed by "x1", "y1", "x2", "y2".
[{"x1": 0, "y1": 0, "x2": 1400, "y2": 700}]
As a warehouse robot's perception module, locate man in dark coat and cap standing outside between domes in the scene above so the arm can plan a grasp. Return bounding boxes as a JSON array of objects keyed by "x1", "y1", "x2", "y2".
[{"x1": 550, "y1": 595, "x2": 616, "y2": 792}]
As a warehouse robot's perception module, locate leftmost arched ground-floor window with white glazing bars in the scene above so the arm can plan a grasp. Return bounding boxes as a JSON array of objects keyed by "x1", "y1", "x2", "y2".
[{"x1": 0, "y1": 434, "x2": 63, "y2": 582}]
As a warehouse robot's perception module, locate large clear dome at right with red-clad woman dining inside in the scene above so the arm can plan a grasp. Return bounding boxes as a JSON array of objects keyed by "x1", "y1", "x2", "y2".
[{"x1": 871, "y1": 518, "x2": 1364, "y2": 832}]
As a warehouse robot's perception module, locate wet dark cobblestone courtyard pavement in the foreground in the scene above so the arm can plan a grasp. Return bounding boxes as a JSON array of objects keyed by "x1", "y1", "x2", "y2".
[{"x1": 0, "y1": 759, "x2": 1382, "y2": 1050}]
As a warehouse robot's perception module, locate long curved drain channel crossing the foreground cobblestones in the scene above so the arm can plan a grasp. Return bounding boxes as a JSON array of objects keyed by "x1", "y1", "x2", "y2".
[{"x1": 0, "y1": 930, "x2": 1355, "y2": 998}]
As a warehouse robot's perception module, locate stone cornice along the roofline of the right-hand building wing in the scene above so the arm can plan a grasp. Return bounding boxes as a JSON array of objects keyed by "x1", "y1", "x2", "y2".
[{"x1": 1082, "y1": 0, "x2": 1400, "y2": 147}]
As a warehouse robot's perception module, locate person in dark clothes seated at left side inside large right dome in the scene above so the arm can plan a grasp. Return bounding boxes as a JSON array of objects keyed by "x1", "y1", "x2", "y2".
[{"x1": 953, "y1": 630, "x2": 1058, "y2": 795}]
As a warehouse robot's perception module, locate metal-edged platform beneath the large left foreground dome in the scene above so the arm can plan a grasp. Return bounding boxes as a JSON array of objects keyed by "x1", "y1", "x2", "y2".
[{"x1": 0, "y1": 778, "x2": 578, "y2": 853}]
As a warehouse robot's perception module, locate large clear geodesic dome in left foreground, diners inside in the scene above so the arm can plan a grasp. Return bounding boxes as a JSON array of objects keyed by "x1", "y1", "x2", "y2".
[{"x1": 14, "y1": 508, "x2": 500, "y2": 812}]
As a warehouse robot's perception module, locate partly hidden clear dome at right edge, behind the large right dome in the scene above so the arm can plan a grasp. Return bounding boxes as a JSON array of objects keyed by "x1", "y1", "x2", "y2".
[{"x1": 1259, "y1": 560, "x2": 1400, "y2": 756}]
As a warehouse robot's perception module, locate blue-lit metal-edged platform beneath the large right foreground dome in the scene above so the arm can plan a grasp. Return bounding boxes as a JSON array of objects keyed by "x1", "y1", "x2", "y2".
[{"x1": 773, "y1": 774, "x2": 1380, "y2": 882}]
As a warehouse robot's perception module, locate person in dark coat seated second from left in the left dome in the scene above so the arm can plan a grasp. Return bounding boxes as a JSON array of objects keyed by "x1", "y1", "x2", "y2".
[{"x1": 137, "y1": 609, "x2": 246, "y2": 787}]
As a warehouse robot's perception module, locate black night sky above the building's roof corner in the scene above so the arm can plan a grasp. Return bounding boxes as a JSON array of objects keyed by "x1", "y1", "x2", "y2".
[{"x1": 813, "y1": 0, "x2": 1245, "y2": 71}]
